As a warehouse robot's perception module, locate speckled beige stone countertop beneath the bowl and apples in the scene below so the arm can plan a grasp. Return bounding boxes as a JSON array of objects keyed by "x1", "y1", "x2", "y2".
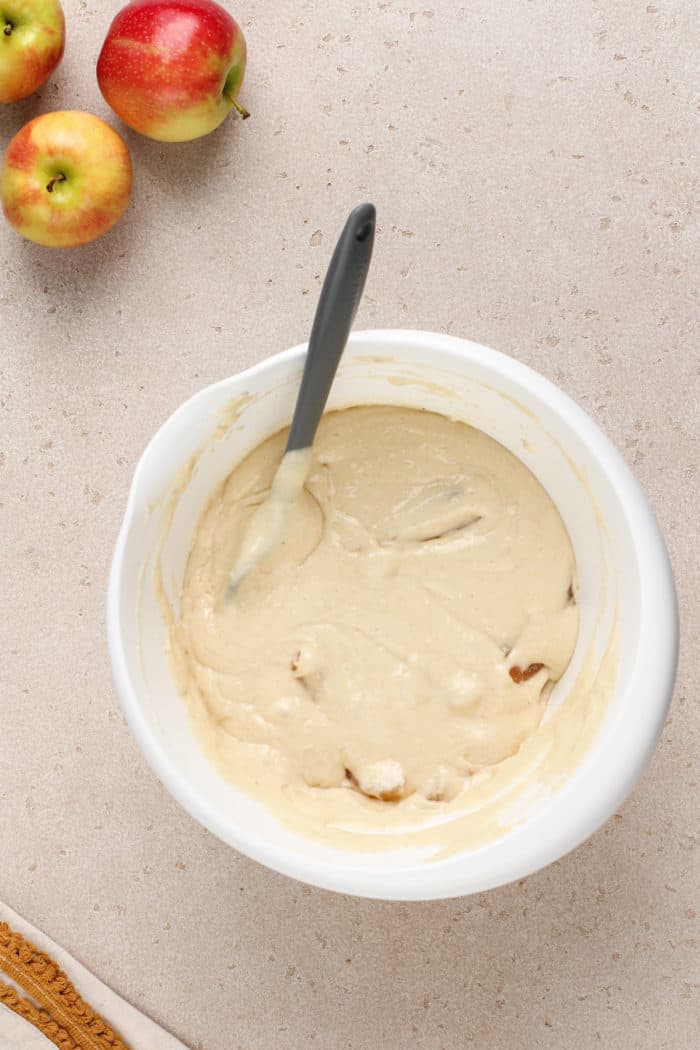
[{"x1": 0, "y1": 0, "x2": 700, "y2": 1050}]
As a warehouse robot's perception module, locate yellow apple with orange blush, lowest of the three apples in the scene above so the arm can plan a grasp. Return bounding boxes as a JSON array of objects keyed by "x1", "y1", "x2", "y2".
[{"x1": 0, "y1": 111, "x2": 131, "y2": 248}]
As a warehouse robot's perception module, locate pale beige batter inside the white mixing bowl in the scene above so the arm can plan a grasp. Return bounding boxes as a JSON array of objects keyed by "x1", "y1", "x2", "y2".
[{"x1": 165, "y1": 406, "x2": 580, "y2": 833}]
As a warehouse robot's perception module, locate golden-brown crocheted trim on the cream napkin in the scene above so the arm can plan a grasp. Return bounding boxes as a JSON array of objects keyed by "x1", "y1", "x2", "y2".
[{"x1": 0, "y1": 922, "x2": 129, "y2": 1050}]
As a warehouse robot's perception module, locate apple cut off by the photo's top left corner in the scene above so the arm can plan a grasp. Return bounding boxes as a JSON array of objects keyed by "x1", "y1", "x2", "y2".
[{"x1": 0, "y1": 0, "x2": 65, "y2": 102}]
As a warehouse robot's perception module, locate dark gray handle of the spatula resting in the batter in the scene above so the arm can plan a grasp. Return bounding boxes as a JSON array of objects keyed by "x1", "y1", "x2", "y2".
[{"x1": 287, "y1": 204, "x2": 377, "y2": 452}]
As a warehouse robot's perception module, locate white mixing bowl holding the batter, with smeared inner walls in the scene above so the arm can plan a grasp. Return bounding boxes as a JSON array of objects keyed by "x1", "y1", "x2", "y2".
[{"x1": 107, "y1": 331, "x2": 678, "y2": 900}]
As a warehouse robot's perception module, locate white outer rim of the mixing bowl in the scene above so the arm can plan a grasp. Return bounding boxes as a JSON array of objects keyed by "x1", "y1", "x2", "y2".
[{"x1": 106, "y1": 329, "x2": 679, "y2": 900}]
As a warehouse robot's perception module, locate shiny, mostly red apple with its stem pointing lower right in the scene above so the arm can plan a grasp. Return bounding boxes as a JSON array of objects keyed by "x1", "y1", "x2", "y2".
[{"x1": 98, "y1": 0, "x2": 250, "y2": 142}]
